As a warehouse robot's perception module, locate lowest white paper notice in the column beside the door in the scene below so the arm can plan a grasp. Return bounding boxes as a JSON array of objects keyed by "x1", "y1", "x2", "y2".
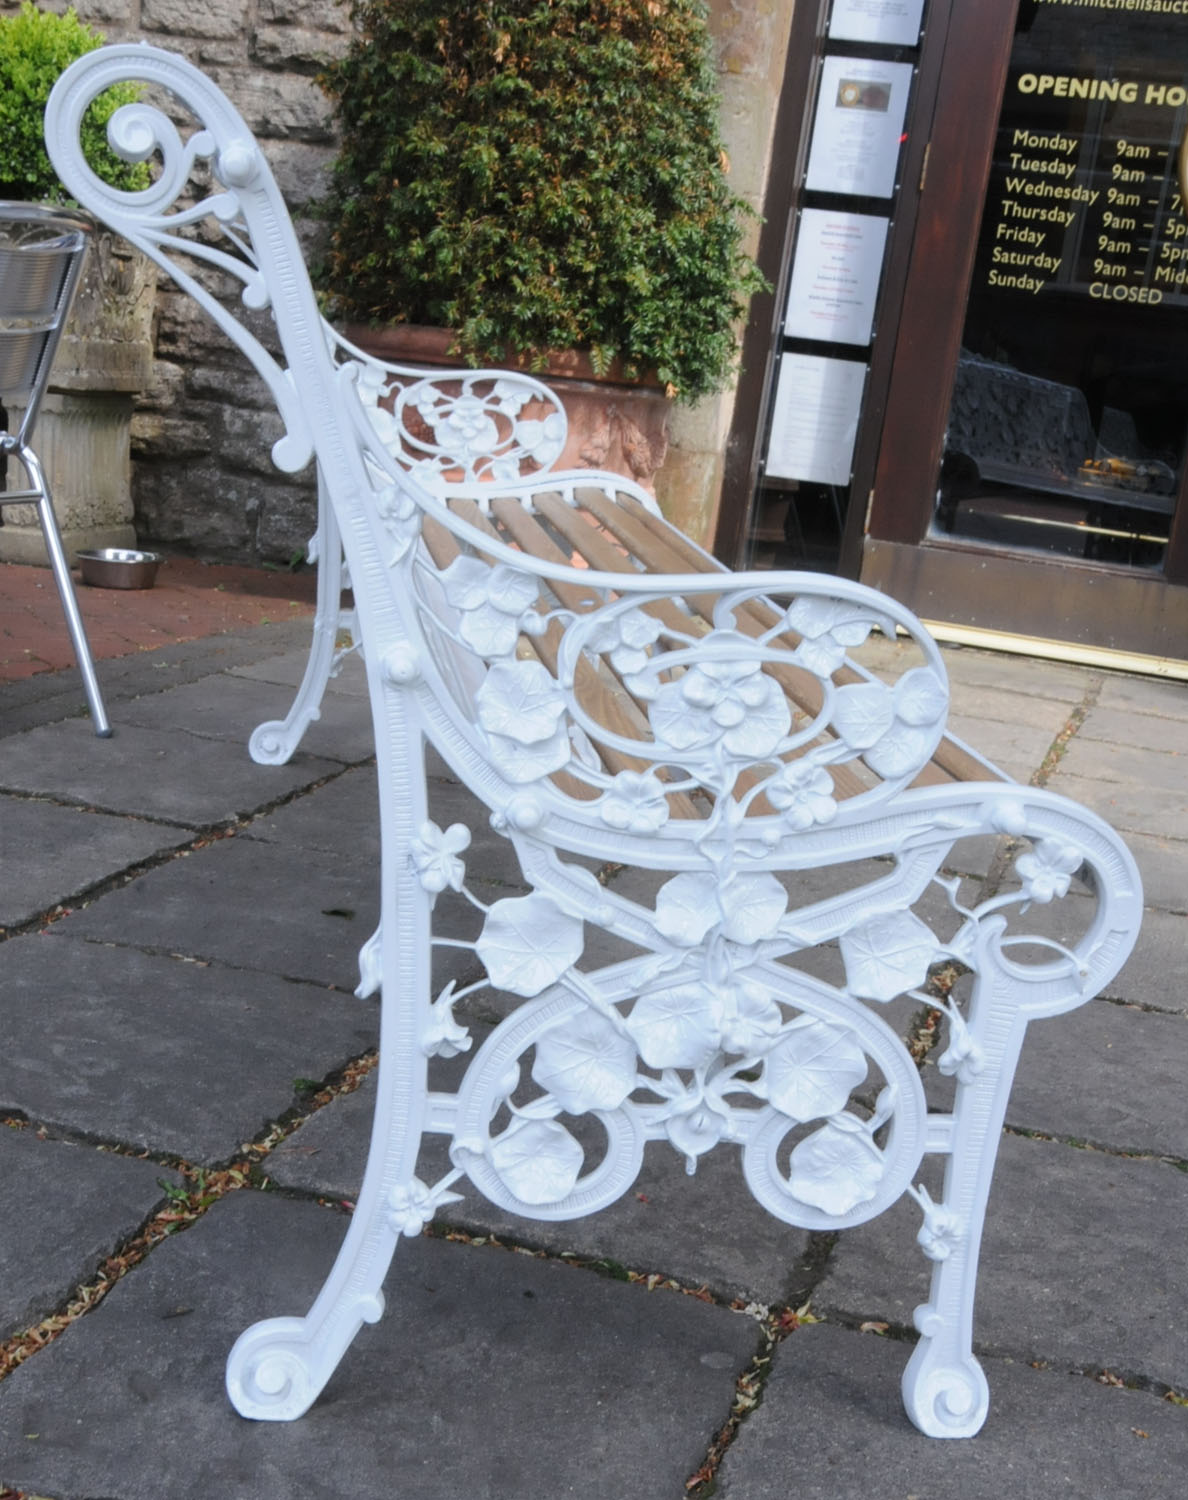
[{"x1": 767, "y1": 354, "x2": 867, "y2": 485}]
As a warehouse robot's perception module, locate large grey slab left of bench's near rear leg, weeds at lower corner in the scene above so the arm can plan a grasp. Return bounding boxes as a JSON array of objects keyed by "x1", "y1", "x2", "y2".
[{"x1": 0, "y1": 935, "x2": 378, "y2": 1163}]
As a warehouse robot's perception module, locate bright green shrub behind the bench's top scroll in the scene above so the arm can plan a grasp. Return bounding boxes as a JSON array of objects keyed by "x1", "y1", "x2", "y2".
[{"x1": 0, "y1": 0, "x2": 149, "y2": 203}]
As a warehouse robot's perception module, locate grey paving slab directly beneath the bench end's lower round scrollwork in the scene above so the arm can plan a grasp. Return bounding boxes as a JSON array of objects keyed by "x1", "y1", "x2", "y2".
[{"x1": 267, "y1": 1074, "x2": 809, "y2": 1304}]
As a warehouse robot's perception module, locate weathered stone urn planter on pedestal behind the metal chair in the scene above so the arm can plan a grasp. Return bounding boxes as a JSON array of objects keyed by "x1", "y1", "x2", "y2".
[{"x1": 0, "y1": 231, "x2": 156, "y2": 566}]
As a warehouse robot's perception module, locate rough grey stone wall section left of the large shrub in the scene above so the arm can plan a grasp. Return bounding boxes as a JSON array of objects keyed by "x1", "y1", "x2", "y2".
[{"x1": 0, "y1": 0, "x2": 350, "y2": 563}]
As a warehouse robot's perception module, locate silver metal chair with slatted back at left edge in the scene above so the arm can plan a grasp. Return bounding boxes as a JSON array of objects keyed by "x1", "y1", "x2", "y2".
[{"x1": 0, "y1": 203, "x2": 111, "y2": 740}]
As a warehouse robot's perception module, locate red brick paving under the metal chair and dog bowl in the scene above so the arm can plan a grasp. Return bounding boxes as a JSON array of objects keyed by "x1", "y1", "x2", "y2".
[{"x1": 0, "y1": 557, "x2": 317, "y2": 683}]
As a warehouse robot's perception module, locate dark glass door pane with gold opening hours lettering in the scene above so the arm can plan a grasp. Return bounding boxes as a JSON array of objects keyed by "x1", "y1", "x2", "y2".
[{"x1": 933, "y1": 0, "x2": 1188, "y2": 572}]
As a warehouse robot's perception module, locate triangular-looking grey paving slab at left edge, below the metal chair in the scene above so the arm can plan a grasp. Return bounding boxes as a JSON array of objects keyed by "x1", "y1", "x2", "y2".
[{"x1": 0, "y1": 797, "x2": 191, "y2": 929}]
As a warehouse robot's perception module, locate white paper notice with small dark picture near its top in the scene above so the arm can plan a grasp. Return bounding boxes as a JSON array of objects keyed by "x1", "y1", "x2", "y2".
[{"x1": 804, "y1": 57, "x2": 912, "y2": 198}]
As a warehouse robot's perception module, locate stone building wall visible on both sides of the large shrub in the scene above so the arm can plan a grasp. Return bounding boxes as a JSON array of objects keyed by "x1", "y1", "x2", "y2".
[{"x1": 0, "y1": 0, "x2": 794, "y2": 563}]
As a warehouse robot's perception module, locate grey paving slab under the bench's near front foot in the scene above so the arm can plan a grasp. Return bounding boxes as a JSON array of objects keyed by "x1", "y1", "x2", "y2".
[{"x1": 714, "y1": 1326, "x2": 1188, "y2": 1500}]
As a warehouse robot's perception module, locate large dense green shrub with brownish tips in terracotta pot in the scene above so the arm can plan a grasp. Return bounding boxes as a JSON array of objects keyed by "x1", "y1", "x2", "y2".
[{"x1": 318, "y1": 0, "x2": 764, "y2": 401}]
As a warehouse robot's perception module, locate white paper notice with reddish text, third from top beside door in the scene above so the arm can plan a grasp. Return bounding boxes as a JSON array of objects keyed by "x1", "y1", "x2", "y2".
[{"x1": 785, "y1": 209, "x2": 888, "y2": 344}]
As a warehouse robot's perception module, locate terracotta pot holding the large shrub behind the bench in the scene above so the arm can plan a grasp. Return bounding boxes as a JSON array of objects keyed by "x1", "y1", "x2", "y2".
[{"x1": 344, "y1": 323, "x2": 672, "y2": 494}]
